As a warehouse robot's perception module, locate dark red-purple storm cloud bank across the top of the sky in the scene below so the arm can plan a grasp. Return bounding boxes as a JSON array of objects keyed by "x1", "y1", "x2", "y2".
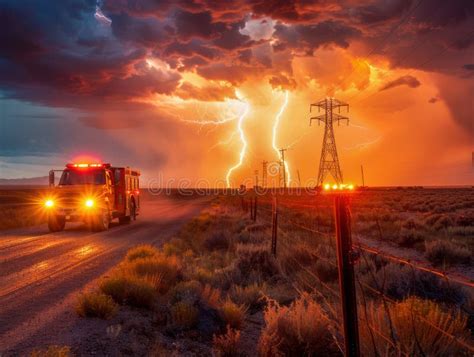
[{"x1": 0, "y1": 0, "x2": 474, "y2": 108}]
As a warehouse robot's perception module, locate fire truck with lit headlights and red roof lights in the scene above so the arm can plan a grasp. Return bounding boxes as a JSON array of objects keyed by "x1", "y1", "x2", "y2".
[{"x1": 44, "y1": 163, "x2": 140, "y2": 232}]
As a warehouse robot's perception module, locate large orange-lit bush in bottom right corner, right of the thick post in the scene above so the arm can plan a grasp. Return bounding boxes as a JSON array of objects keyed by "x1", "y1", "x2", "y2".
[{"x1": 360, "y1": 298, "x2": 469, "y2": 356}]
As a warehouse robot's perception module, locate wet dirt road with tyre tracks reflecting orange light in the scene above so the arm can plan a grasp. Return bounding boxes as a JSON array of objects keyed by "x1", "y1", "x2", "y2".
[{"x1": 0, "y1": 198, "x2": 208, "y2": 356}]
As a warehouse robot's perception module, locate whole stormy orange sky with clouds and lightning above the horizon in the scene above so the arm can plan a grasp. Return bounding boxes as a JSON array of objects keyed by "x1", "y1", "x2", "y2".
[{"x1": 0, "y1": 0, "x2": 474, "y2": 187}]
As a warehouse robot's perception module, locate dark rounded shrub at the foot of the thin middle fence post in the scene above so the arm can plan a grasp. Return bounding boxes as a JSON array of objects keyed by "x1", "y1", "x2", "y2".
[{"x1": 236, "y1": 244, "x2": 280, "y2": 279}]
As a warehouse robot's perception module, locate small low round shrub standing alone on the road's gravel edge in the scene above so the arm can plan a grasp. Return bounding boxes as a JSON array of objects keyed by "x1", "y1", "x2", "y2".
[{"x1": 76, "y1": 292, "x2": 117, "y2": 319}]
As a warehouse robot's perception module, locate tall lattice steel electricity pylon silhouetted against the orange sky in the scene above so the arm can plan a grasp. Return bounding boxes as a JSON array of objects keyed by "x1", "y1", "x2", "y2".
[{"x1": 309, "y1": 98, "x2": 349, "y2": 186}]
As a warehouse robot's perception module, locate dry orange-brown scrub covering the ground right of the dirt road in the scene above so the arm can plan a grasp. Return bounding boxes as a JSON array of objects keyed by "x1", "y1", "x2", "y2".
[{"x1": 77, "y1": 191, "x2": 474, "y2": 356}]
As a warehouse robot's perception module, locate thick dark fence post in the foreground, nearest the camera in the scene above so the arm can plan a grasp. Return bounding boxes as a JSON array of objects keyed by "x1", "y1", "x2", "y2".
[{"x1": 334, "y1": 194, "x2": 360, "y2": 357}]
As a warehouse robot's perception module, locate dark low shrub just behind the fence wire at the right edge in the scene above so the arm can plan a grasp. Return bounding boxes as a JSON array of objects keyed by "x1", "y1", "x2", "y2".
[{"x1": 425, "y1": 240, "x2": 471, "y2": 266}]
